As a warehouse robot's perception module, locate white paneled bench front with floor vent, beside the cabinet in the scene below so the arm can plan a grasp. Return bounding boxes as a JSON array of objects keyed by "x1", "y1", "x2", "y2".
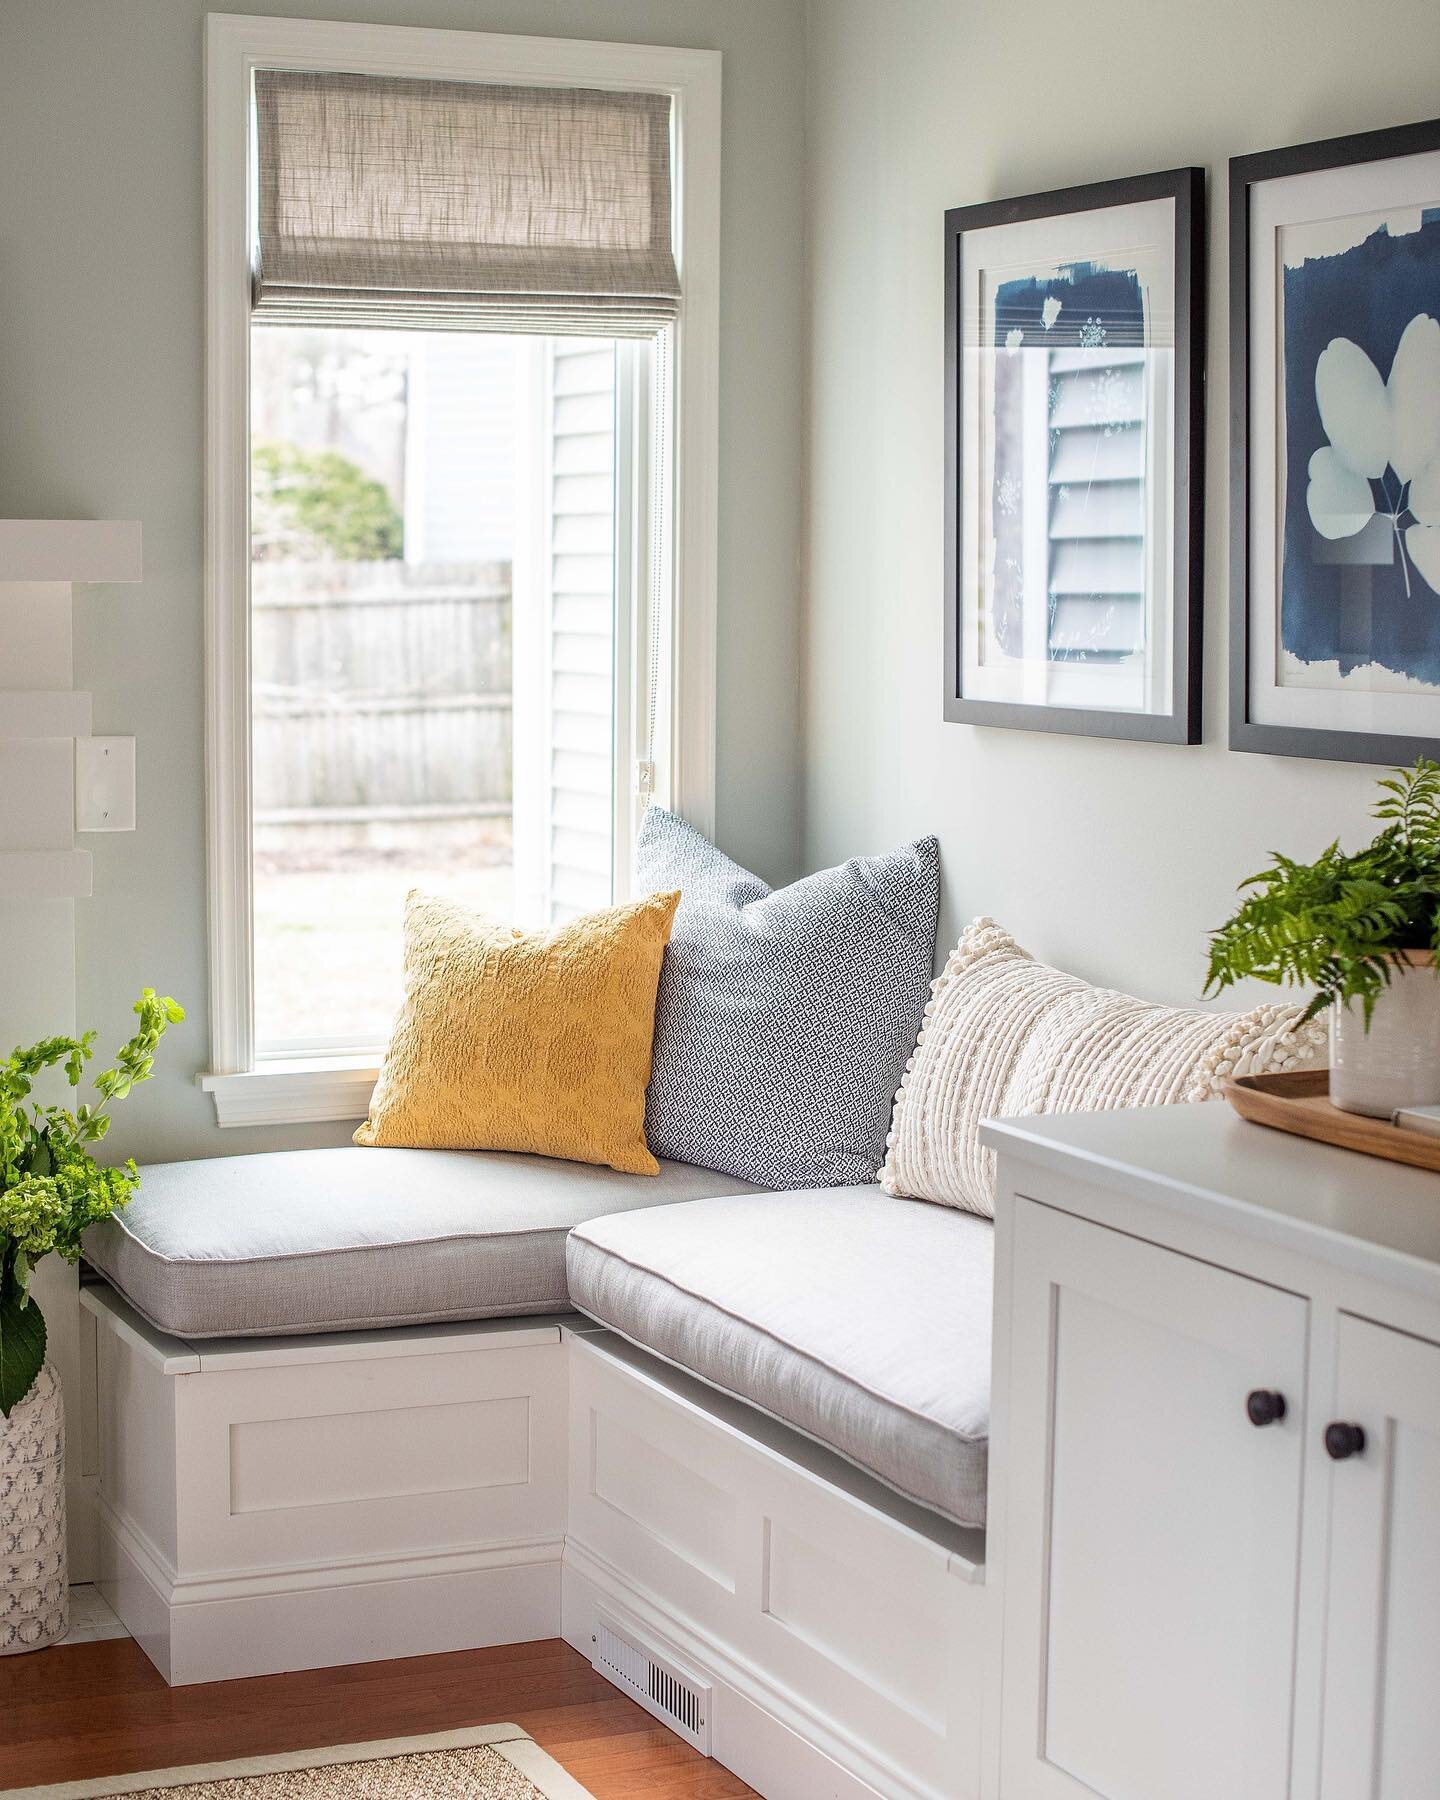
[{"x1": 563, "y1": 1330, "x2": 986, "y2": 1800}]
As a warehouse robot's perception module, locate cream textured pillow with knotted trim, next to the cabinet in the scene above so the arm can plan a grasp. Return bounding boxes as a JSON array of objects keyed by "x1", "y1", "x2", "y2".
[{"x1": 880, "y1": 918, "x2": 1325, "y2": 1219}]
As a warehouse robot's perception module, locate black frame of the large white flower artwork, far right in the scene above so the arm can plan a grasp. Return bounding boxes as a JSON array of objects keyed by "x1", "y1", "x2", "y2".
[{"x1": 1229, "y1": 119, "x2": 1440, "y2": 765}]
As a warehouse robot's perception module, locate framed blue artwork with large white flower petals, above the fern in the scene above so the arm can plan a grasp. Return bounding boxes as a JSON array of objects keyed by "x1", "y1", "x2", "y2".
[{"x1": 1229, "y1": 121, "x2": 1440, "y2": 763}]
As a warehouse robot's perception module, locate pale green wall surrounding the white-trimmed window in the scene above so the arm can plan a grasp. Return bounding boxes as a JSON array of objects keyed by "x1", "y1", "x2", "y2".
[{"x1": 0, "y1": 0, "x2": 803, "y2": 1157}]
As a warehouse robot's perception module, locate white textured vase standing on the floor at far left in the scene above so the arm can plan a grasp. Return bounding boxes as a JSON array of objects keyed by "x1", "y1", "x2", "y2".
[{"x1": 0, "y1": 1363, "x2": 70, "y2": 1656}]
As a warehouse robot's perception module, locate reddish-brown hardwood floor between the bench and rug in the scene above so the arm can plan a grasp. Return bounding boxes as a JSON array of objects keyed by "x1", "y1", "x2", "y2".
[{"x1": 0, "y1": 1638, "x2": 754, "y2": 1800}]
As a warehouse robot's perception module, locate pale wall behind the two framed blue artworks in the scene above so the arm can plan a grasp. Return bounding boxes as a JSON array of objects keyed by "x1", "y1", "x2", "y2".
[{"x1": 803, "y1": 0, "x2": 1440, "y2": 1001}]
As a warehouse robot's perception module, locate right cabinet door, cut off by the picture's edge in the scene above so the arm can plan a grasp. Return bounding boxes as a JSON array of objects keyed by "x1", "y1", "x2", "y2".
[{"x1": 1312, "y1": 1318, "x2": 1440, "y2": 1800}]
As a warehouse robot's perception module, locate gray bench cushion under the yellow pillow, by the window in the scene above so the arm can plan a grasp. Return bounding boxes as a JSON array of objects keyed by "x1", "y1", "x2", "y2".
[{"x1": 85, "y1": 1147, "x2": 745, "y2": 1337}]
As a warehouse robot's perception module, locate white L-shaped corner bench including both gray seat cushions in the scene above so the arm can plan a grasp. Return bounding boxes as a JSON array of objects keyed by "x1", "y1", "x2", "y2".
[{"x1": 83, "y1": 1150, "x2": 992, "y2": 1800}]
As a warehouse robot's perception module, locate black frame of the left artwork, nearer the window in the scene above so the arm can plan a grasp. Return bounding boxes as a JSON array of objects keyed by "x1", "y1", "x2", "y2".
[{"x1": 945, "y1": 167, "x2": 1206, "y2": 743}]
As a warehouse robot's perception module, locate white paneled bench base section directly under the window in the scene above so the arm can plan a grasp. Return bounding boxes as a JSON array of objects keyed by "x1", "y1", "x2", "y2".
[{"x1": 83, "y1": 1285, "x2": 565, "y2": 1685}]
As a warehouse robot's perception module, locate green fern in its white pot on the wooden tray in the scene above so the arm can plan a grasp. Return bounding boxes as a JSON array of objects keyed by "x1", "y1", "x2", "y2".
[{"x1": 1206, "y1": 758, "x2": 1440, "y2": 1118}]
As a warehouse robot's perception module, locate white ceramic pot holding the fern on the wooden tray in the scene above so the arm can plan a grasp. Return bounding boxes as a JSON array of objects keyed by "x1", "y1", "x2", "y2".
[{"x1": 1330, "y1": 950, "x2": 1440, "y2": 1120}]
